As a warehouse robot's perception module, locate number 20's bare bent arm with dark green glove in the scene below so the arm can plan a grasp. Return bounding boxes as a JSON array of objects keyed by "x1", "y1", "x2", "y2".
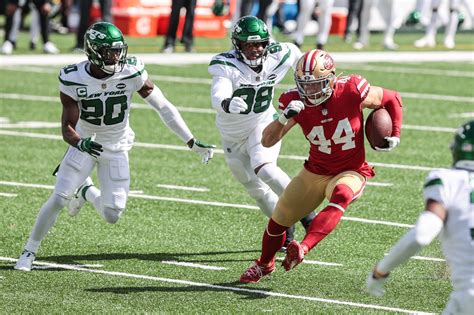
[{"x1": 59, "y1": 92, "x2": 102, "y2": 157}]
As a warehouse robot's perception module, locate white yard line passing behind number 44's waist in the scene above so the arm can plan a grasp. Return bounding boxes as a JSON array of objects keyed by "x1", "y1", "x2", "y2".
[{"x1": 0, "y1": 129, "x2": 433, "y2": 171}]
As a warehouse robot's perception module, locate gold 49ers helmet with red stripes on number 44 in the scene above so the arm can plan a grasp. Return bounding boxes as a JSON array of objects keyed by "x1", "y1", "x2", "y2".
[{"x1": 295, "y1": 49, "x2": 336, "y2": 106}]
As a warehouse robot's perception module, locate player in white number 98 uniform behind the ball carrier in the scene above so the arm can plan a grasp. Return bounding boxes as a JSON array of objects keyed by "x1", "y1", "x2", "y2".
[{"x1": 208, "y1": 15, "x2": 314, "y2": 251}]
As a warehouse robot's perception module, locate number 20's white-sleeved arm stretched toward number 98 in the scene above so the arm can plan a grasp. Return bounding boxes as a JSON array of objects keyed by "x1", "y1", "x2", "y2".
[{"x1": 138, "y1": 80, "x2": 216, "y2": 164}]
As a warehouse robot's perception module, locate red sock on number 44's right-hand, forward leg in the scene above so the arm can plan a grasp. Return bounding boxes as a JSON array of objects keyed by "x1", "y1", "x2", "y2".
[{"x1": 301, "y1": 185, "x2": 354, "y2": 254}]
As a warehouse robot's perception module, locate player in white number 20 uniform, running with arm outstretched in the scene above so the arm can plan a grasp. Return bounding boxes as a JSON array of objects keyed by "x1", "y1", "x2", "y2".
[{"x1": 15, "y1": 22, "x2": 214, "y2": 271}]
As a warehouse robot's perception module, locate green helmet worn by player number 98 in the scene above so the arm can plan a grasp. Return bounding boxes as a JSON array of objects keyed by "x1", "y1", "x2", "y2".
[{"x1": 232, "y1": 15, "x2": 270, "y2": 68}]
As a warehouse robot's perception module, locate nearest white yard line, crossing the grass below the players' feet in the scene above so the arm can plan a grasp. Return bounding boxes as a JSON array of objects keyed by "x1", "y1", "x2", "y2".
[{"x1": 0, "y1": 257, "x2": 433, "y2": 315}]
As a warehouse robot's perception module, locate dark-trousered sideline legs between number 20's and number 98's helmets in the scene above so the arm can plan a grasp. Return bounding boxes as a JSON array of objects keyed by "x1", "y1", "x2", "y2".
[{"x1": 162, "y1": 0, "x2": 196, "y2": 54}]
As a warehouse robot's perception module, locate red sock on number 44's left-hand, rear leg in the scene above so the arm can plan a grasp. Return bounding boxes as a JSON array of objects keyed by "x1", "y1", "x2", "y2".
[{"x1": 259, "y1": 219, "x2": 288, "y2": 264}]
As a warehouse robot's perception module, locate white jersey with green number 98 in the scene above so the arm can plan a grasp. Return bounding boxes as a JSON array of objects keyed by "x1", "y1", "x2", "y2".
[{"x1": 208, "y1": 42, "x2": 301, "y2": 141}]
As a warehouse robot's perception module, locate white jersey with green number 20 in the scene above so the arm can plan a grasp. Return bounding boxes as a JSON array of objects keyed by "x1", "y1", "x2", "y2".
[{"x1": 59, "y1": 57, "x2": 148, "y2": 151}]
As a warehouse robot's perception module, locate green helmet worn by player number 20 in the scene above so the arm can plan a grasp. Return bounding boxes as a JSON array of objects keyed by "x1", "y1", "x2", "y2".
[{"x1": 84, "y1": 22, "x2": 128, "y2": 74}]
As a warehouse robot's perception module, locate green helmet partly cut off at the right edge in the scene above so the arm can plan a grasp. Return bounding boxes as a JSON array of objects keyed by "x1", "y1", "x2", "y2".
[{"x1": 450, "y1": 120, "x2": 474, "y2": 171}]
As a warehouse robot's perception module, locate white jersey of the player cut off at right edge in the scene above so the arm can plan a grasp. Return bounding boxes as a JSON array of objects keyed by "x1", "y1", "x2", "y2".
[{"x1": 423, "y1": 169, "x2": 474, "y2": 290}]
